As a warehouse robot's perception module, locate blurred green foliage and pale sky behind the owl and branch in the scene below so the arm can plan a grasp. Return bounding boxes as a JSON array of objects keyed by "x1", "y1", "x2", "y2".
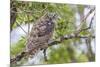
[{"x1": 10, "y1": 1, "x2": 96, "y2": 65}]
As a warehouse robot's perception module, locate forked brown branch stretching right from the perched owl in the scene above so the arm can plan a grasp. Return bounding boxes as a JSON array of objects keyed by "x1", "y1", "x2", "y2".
[{"x1": 48, "y1": 8, "x2": 95, "y2": 46}]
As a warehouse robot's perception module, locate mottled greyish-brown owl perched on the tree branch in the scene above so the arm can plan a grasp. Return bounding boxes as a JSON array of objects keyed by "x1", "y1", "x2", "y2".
[{"x1": 26, "y1": 13, "x2": 56, "y2": 54}]
